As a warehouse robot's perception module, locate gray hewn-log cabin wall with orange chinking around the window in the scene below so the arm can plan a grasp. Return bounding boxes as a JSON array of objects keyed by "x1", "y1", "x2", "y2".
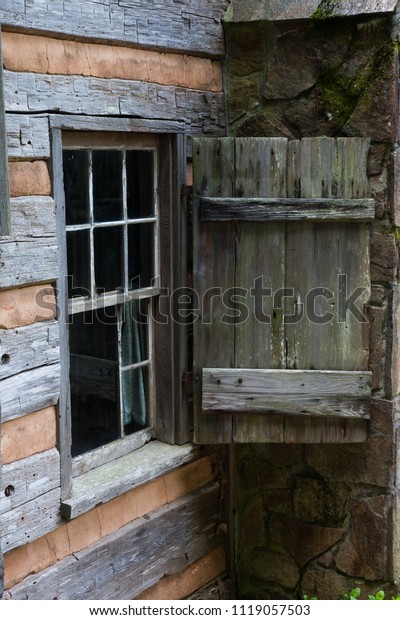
[{"x1": 0, "y1": 0, "x2": 227, "y2": 599}]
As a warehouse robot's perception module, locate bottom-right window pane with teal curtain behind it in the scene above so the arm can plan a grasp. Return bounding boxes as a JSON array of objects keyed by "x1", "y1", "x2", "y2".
[{"x1": 122, "y1": 366, "x2": 149, "y2": 435}]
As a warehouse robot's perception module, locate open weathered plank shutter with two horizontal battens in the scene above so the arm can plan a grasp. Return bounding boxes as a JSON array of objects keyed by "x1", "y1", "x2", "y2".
[{"x1": 193, "y1": 138, "x2": 374, "y2": 443}]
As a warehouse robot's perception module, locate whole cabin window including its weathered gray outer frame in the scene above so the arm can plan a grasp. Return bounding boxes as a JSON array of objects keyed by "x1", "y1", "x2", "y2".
[{"x1": 50, "y1": 123, "x2": 189, "y2": 496}]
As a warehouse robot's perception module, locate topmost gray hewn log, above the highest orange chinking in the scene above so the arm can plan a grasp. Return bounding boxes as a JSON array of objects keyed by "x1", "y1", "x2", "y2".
[{"x1": 0, "y1": 0, "x2": 228, "y2": 56}]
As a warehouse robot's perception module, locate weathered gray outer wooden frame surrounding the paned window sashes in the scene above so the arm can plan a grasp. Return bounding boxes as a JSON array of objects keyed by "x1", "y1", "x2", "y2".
[{"x1": 50, "y1": 115, "x2": 189, "y2": 500}]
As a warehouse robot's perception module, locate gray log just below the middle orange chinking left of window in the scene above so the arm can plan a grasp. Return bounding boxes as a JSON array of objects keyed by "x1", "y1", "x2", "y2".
[{"x1": 0, "y1": 322, "x2": 60, "y2": 379}]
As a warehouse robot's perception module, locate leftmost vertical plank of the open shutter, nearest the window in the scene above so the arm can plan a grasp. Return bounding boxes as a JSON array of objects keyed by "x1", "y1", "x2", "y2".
[{"x1": 193, "y1": 138, "x2": 235, "y2": 444}]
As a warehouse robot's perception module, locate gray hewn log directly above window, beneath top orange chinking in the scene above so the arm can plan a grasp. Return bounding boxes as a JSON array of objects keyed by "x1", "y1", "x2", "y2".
[{"x1": 4, "y1": 71, "x2": 225, "y2": 134}]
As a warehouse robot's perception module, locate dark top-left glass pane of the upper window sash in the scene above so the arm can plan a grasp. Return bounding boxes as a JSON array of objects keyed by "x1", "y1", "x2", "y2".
[{"x1": 63, "y1": 150, "x2": 89, "y2": 226}]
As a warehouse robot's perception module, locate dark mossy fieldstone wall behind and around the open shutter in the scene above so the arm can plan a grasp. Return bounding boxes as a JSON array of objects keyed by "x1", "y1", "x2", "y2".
[{"x1": 226, "y1": 16, "x2": 400, "y2": 599}]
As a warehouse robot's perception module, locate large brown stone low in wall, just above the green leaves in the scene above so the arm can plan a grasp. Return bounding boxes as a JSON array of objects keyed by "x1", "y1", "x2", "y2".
[{"x1": 336, "y1": 495, "x2": 387, "y2": 581}]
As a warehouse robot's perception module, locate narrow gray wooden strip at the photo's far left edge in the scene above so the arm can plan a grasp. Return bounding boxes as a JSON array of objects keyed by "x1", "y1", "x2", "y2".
[{"x1": 0, "y1": 27, "x2": 11, "y2": 236}]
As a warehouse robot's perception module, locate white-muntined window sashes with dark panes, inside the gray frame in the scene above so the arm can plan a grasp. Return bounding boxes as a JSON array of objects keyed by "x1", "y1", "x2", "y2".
[{"x1": 63, "y1": 135, "x2": 158, "y2": 456}]
